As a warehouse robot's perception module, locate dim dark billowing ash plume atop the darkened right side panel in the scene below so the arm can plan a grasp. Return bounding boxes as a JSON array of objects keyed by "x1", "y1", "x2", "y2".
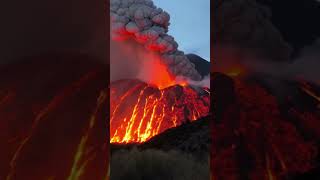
[{"x1": 213, "y1": 0, "x2": 292, "y2": 61}]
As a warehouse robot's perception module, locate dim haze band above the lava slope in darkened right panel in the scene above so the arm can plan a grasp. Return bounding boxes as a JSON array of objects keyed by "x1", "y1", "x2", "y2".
[{"x1": 213, "y1": 40, "x2": 320, "y2": 85}]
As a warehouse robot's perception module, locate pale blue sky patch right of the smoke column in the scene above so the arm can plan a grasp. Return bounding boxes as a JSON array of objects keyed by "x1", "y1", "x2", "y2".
[{"x1": 153, "y1": 0, "x2": 210, "y2": 61}]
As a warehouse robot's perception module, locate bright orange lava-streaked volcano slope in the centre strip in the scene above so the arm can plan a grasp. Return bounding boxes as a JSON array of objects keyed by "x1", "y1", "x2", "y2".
[{"x1": 110, "y1": 80, "x2": 210, "y2": 143}]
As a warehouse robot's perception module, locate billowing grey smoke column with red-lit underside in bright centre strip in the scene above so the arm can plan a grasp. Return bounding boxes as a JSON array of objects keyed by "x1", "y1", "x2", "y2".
[{"x1": 110, "y1": 0, "x2": 201, "y2": 81}]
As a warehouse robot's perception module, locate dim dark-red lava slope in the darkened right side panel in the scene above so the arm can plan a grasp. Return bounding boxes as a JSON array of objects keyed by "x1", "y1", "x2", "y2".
[{"x1": 211, "y1": 73, "x2": 320, "y2": 180}]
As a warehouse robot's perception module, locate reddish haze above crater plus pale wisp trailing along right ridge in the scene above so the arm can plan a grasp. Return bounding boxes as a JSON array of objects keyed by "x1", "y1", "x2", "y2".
[{"x1": 110, "y1": 41, "x2": 210, "y2": 88}]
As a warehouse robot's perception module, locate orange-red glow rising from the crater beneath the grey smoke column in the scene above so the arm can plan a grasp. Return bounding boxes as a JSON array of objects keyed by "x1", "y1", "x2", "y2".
[{"x1": 111, "y1": 40, "x2": 187, "y2": 89}]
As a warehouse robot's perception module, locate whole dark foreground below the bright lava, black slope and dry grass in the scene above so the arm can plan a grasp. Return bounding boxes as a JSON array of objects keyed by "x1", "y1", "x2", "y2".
[{"x1": 110, "y1": 116, "x2": 211, "y2": 180}]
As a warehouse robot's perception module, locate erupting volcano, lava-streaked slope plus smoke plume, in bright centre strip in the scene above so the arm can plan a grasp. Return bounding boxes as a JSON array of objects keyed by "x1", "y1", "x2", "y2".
[{"x1": 110, "y1": 0, "x2": 210, "y2": 143}]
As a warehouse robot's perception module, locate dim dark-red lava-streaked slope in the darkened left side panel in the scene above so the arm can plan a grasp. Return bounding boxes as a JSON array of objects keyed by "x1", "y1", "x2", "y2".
[{"x1": 0, "y1": 54, "x2": 109, "y2": 180}]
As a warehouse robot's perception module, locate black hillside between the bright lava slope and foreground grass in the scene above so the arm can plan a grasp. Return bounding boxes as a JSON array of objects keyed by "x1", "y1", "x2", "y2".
[{"x1": 110, "y1": 115, "x2": 213, "y2": 165}]
